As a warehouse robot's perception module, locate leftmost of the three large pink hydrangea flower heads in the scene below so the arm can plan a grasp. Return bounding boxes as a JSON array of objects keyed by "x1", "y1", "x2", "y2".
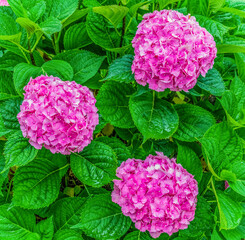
[{"x1": 17, "y1": 75, "x2": 99, "y2": 155}]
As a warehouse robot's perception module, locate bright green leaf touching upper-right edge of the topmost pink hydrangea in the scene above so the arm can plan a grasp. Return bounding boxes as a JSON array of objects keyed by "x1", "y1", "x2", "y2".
[{"x1": 195, "y1": 15, "x2": 230, "y2": 41}]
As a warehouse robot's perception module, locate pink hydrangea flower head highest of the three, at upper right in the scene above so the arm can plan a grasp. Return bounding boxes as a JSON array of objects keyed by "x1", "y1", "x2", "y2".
[{"x1": 132, "y1": 10, "x2": 217, "y2": 91}]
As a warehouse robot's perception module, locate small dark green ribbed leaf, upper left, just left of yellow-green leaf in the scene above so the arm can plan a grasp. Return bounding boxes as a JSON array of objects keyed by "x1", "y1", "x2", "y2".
[{"x1": 64, "y1": 23, "x2": 92, "y2": 50}]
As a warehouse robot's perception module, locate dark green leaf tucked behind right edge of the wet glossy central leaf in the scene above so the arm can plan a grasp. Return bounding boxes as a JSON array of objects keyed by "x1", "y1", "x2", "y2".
[{"x1": 173, "y1": 104, "x2": 215, "y2": 142}]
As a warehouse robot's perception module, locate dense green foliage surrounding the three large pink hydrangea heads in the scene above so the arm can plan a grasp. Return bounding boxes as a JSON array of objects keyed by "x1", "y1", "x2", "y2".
[{"x1": 0, "y1": 0, "x2": 245, "y2": 240}]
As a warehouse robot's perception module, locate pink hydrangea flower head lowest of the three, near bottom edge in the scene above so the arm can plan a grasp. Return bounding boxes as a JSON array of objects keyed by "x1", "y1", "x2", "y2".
[{"x1": 112, "y1": 152, "x2": 198, "y2": 238}]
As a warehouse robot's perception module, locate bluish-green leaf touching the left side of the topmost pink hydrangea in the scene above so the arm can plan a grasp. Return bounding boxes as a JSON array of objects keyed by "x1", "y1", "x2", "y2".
[{"x1": 103, "y1": 55, "x2": 134, "y2": 83}]
